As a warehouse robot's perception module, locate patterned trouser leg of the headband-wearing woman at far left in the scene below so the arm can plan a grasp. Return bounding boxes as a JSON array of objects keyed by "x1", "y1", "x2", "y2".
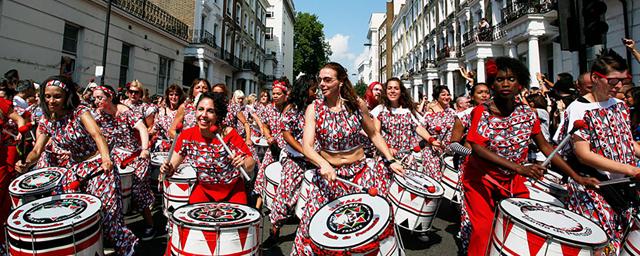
[{"x1": 81, "y1": 159, "x2": 138, "y2": 255}]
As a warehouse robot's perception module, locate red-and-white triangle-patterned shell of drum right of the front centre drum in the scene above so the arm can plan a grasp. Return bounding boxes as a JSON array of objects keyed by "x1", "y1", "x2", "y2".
[{"x1": 388, "y1": 174, "x2": 443, "y2": 232}]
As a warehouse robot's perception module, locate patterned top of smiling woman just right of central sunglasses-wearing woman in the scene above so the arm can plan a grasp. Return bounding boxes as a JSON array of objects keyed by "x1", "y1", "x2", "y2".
[{"x1": 371, "y1": 105, "x2": 419, "y2": 153}]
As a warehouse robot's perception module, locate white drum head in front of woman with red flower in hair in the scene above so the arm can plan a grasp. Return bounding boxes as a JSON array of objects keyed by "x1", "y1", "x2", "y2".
[{"x1": 500, "y1": 198, "x2": 608, "y2": 247}]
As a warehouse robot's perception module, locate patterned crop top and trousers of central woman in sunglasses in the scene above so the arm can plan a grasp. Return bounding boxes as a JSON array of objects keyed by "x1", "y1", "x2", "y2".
[{"x1": 291, "y1": 99, "x2": 382, "y2": 255}]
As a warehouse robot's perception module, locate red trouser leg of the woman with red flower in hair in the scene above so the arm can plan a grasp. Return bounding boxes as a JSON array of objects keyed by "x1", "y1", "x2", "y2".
[{"x1": 463, "y1": 170, "x2": 494, "y2": 255}]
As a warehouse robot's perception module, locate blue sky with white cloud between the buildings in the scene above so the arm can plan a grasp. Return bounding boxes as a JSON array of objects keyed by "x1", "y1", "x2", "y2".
[{"x1": 294, "y1": 0, "x2": 386, "y2": 82}]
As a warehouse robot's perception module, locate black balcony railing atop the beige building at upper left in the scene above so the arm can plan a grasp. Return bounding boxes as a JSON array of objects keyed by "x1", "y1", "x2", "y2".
[{"x1": 112, "y1": 0, "x2": 189, "y2": 41}]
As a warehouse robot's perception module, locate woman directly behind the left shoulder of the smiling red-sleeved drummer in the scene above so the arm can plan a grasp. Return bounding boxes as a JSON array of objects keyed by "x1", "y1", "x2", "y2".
[{"x1": 169, "y1": 78, "x2": 211, "y2": 138}]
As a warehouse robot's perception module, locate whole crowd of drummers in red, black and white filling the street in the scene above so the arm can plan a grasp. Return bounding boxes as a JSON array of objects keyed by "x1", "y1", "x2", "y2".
[{"x1": 0, "y1": 44, "x2": 640, "y2": 255}]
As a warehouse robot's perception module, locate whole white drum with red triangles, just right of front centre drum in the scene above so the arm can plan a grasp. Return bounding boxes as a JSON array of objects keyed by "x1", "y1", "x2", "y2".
[{"x1": 388, "y1": 171, "x2": 444, "y2": 232}]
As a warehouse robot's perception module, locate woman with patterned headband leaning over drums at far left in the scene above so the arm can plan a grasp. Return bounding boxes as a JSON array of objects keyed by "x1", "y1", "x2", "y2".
[{"x1": 17, "y1": 76, "x2": 138, "y2": 255}]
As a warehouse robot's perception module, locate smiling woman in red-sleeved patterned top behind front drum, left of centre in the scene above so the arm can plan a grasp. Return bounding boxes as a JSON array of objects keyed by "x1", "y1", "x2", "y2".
[{"x1": 160, "y1": 93, "x2": 255, "y2": 204}]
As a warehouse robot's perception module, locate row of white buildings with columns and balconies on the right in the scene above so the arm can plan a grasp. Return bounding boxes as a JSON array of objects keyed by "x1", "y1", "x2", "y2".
[{"x1": 388, "y1": 0, "x2": 640, "y2": 102}]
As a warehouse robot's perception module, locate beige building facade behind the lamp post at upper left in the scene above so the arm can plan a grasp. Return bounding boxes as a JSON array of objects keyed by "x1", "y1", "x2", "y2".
[{"x1": 0, "y1": 0, "x2": 188, "y2": 94}]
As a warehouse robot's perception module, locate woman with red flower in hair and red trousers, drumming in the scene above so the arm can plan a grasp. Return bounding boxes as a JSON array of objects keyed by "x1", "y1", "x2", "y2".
[{"x1": 462, "y1": 57, "x2": 595, "y2": 255}]
